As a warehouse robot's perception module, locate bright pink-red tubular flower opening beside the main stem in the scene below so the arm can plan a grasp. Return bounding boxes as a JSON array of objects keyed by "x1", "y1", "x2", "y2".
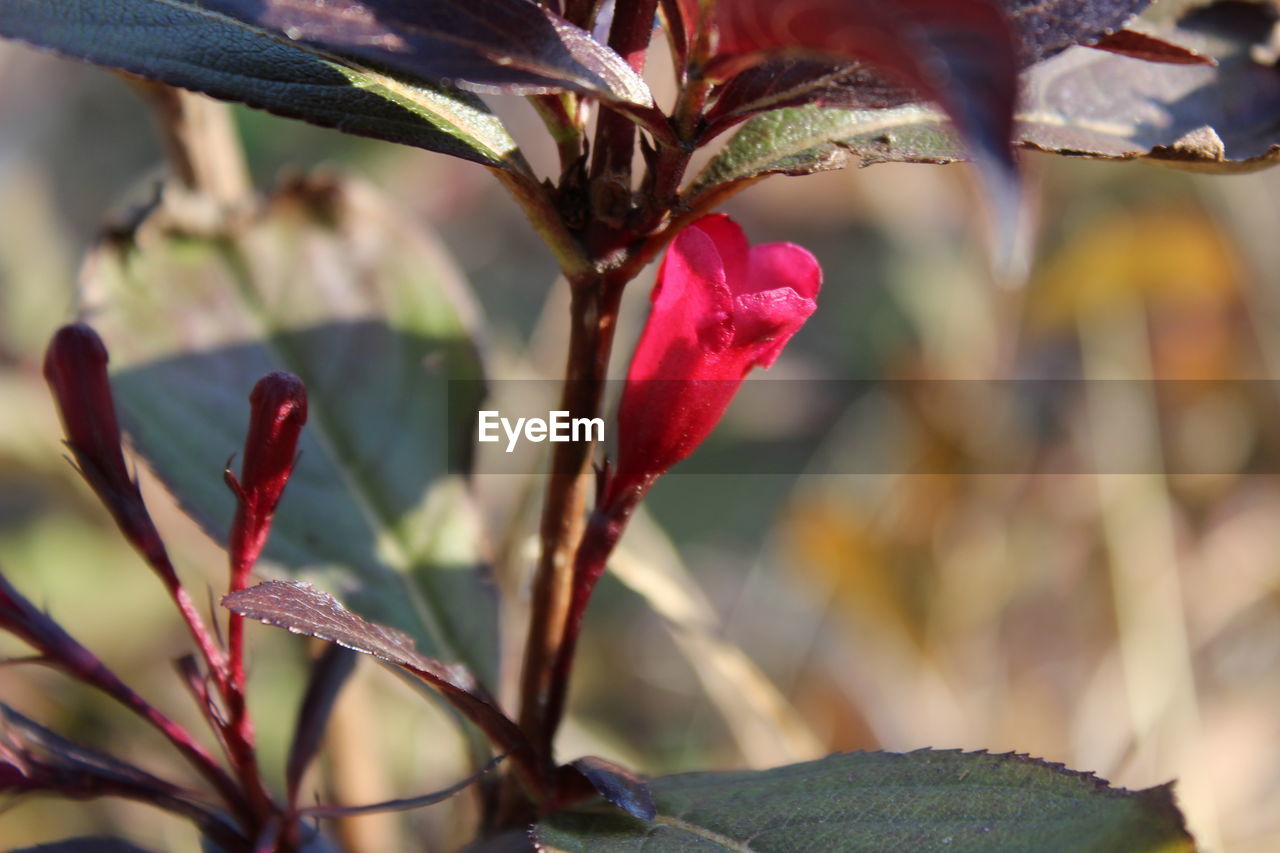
[{"x1": 604, "y1": 214, "x2": 822, "y2": 506}]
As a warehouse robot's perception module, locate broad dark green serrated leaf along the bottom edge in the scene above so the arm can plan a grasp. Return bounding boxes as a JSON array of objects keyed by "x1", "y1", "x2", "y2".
[{"x1": 534, "y1": 749, "x2": 1196, "y2": 853}]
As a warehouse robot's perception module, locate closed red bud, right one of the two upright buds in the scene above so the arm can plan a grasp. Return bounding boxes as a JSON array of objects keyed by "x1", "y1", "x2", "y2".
[{"x1": 227, "y1": 371, "x2": 307, "y2": 578}]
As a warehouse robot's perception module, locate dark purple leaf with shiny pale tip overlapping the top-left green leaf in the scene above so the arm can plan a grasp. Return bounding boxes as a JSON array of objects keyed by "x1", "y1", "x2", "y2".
[{"x1": 204, "y1": 0, "x2": 653, "y2": 106}]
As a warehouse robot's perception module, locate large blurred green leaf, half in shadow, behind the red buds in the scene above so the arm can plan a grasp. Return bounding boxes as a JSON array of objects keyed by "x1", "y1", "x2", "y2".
[{"x1": 84, "y1": 172, "x2": 497, "y2": 684}]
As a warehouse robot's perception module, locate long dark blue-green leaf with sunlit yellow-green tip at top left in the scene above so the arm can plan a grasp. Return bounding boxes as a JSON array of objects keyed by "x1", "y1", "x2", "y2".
[{"x1": 0, "y1": 0, "x2": 526, "y2": 170}]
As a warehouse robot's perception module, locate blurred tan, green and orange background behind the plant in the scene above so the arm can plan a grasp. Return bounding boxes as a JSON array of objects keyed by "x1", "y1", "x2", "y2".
[{"x1": 0, "y1": 21, "x2": 1280, "y2": 853}]
